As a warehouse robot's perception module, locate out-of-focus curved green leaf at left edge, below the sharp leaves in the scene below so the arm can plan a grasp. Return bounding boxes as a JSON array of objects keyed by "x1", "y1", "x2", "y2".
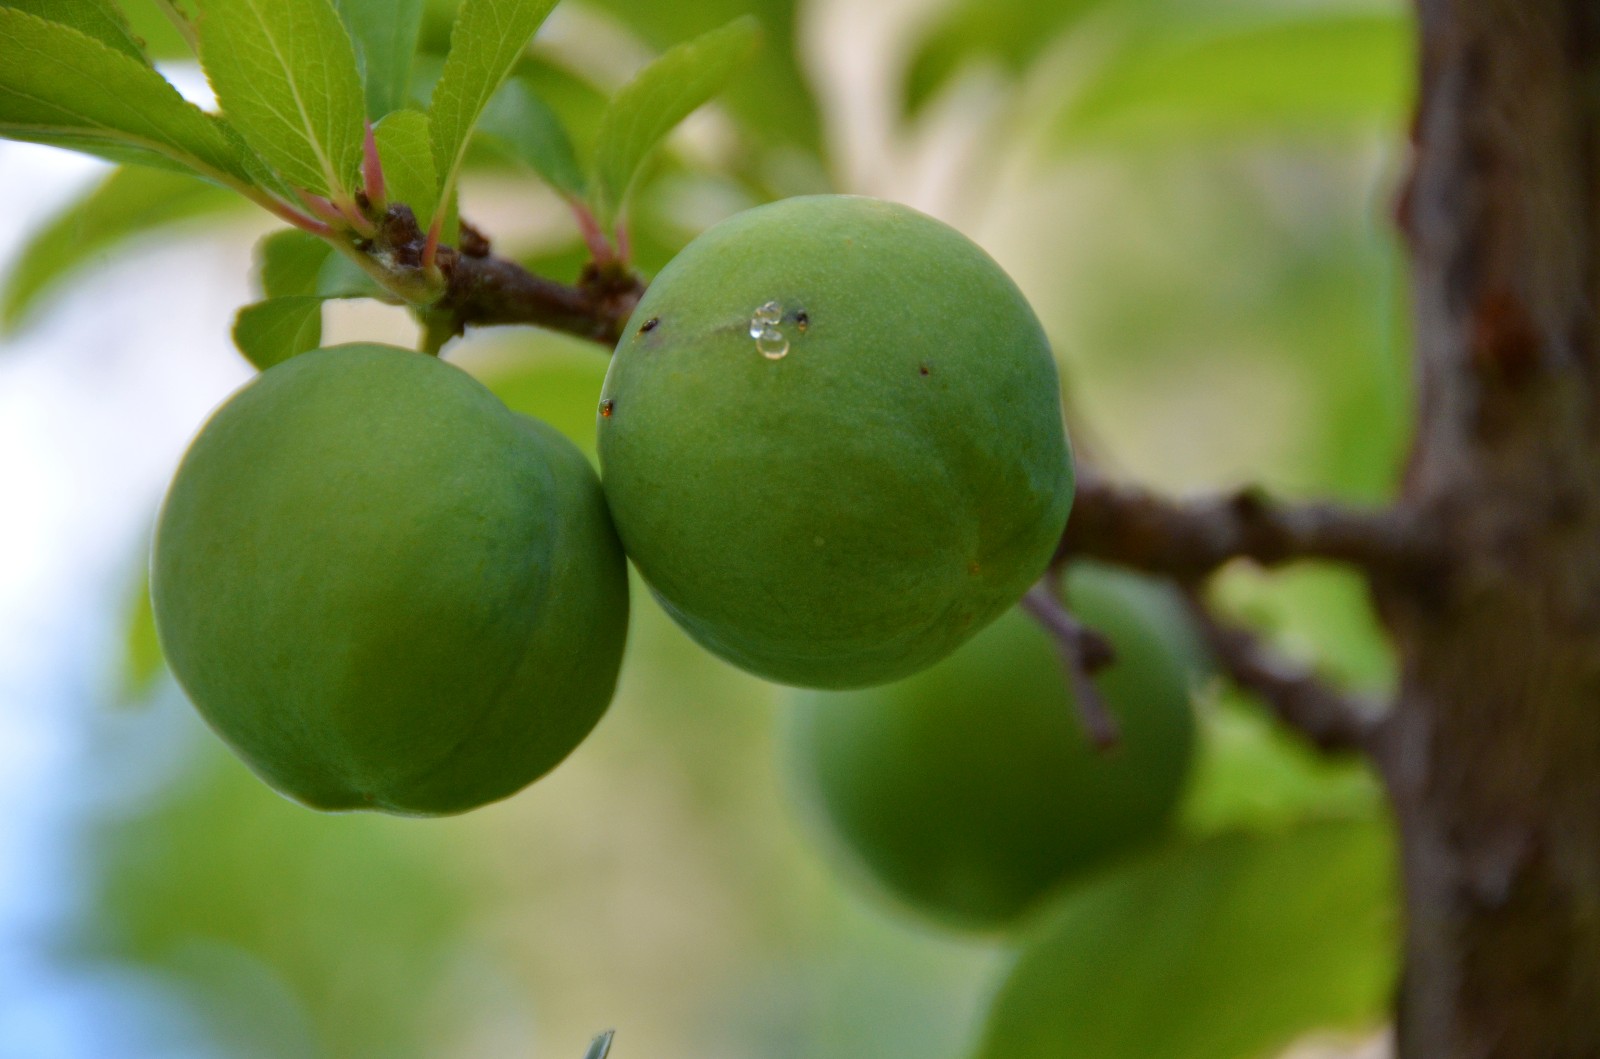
[{"x1": 0, "y1": 168, "x2": 245, "y2": 333}]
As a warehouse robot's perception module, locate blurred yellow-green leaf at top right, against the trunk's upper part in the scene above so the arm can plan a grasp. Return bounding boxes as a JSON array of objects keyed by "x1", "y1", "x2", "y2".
[{"x1": 1056, "y1": 13, "x2": 1411, "y2": 144}]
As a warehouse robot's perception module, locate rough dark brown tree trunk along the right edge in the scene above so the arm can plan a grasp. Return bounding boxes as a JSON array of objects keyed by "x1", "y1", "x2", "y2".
[{"x1": 1376, "y1": 0, "x2": 1600, "y2": 1059}]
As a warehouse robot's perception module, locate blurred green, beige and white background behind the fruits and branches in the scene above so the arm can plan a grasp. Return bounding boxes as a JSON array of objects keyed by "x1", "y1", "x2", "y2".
[{"x1": 0, "y1": 0, "x2": 1413, "y2": 1059}]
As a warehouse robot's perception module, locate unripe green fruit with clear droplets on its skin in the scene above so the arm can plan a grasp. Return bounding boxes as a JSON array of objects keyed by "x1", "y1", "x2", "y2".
[{"x1": 600, "y1": 195, "x2": 1072, "y2": 688}]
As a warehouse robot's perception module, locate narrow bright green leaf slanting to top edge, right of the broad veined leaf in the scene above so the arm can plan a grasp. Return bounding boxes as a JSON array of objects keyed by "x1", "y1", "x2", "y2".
[{"x1": 419, "y1": 0, "x2": 555, "y2": 228}]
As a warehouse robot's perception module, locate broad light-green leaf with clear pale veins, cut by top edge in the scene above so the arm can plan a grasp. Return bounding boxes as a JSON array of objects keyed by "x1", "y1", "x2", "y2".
[{"x1": 200, "y1": 0, "x2": 366, "y2": 200}]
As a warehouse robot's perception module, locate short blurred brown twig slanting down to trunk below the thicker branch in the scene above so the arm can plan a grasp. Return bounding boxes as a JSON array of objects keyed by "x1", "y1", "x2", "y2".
[{"x1": 1187, "y1": 593, "x2": 1384, "y2": 753}]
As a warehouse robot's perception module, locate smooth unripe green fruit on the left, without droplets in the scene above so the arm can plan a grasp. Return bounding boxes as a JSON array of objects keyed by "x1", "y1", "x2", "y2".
[{"x1": 150, "y1": 346, "x2": 627, "y2": 814}]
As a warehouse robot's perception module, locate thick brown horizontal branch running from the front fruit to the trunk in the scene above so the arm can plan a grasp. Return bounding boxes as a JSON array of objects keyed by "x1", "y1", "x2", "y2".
[{"x1": 1054, "y1": 474, "x2": 1434, "y2": 584}]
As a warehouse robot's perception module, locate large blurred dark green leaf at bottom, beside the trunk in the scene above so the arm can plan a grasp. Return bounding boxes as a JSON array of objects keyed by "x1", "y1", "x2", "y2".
[{"x1": 976, "y1": 821, "x2": 1398, "y2": 1059}]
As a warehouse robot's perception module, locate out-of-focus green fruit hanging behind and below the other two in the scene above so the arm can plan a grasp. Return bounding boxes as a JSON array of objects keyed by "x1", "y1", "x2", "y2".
[{"x1": 787, "y1": 566, "x2": 1195, "y2": 928}]
